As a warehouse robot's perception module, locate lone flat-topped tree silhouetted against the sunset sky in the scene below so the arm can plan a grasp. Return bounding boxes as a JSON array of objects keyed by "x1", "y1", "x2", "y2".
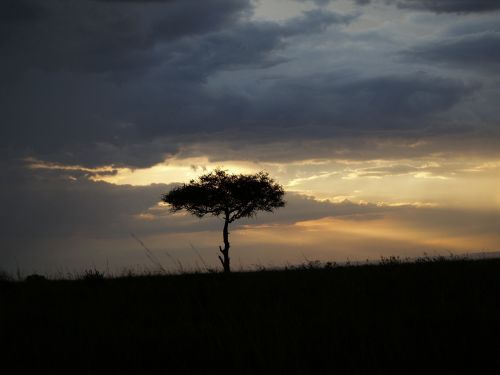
[{"x1": 162, "y1": 169, "x2": 285, "y2": 272}]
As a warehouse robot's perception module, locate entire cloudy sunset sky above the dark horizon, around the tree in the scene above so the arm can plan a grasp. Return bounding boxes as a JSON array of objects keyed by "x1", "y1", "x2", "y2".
[{"x1": 0, "y1": 0, "x2": 500, "y2": 274}]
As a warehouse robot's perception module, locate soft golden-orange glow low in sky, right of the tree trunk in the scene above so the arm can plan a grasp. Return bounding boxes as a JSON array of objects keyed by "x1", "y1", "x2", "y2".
[{"x1": 233, "y1": 216, "x2": 500, "y2": 260}]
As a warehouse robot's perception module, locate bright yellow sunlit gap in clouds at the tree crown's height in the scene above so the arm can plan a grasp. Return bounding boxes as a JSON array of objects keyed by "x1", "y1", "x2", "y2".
[{"x1": 26, "y1": 156, "x2": 500, "y2": 210}]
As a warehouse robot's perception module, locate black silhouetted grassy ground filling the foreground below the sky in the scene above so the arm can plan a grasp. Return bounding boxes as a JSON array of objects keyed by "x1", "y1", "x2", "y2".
[{"x1": 0, "y1": 259, "x2": 500, "y2": 374}]
